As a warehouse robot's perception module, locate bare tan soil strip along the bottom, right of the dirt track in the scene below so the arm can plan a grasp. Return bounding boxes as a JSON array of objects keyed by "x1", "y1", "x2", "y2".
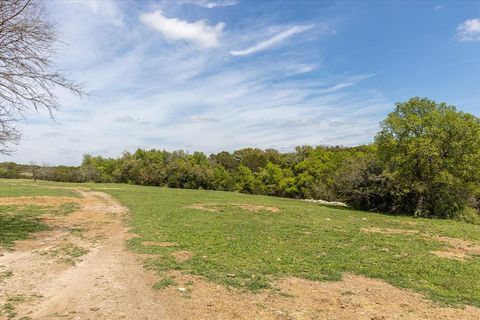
[{"x1": 152, "y1": 272, "x2": 480, "y2": 320}]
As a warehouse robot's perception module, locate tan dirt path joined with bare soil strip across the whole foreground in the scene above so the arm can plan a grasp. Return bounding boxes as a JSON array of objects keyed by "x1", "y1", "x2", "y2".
[{"x1": 0, "y1": 190, "x2": 480, "y2": 320}]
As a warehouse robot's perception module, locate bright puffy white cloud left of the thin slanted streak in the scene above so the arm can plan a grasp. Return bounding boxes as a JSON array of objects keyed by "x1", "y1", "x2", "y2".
[{"x1": 140, "y1": 10, "x2": 225, "y2": 48}]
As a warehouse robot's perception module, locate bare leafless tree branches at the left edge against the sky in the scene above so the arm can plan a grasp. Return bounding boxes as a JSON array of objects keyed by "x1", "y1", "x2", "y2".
[{"x1": 0, "y1": 0, "x2": 82, "y2": 154}]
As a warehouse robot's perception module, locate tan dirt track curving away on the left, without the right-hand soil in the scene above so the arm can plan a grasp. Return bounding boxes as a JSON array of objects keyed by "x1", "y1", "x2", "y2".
[{"x1": 0, "y1": 191, "x2": 165, "y2": 319}]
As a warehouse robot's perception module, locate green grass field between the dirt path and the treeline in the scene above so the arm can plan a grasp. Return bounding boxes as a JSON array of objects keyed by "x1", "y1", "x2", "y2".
[{"x1": 0, "y1": 181, "x2": 480, "y2": 306}]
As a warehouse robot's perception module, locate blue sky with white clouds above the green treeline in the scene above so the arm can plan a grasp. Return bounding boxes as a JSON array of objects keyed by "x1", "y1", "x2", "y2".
[{"x1": 2, "y1": 0, "x2": 480, "y2": 164}]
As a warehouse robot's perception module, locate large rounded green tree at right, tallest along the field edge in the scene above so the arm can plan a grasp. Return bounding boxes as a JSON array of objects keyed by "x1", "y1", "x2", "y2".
[{"x1": 376, "y1": 98, "x2": 480, "y2": 219}]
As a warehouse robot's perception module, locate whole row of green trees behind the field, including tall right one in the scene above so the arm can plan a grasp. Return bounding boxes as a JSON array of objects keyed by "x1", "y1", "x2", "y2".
[{"x1": 0, "y1": 98, "x2": 480, "y2": 222}]
